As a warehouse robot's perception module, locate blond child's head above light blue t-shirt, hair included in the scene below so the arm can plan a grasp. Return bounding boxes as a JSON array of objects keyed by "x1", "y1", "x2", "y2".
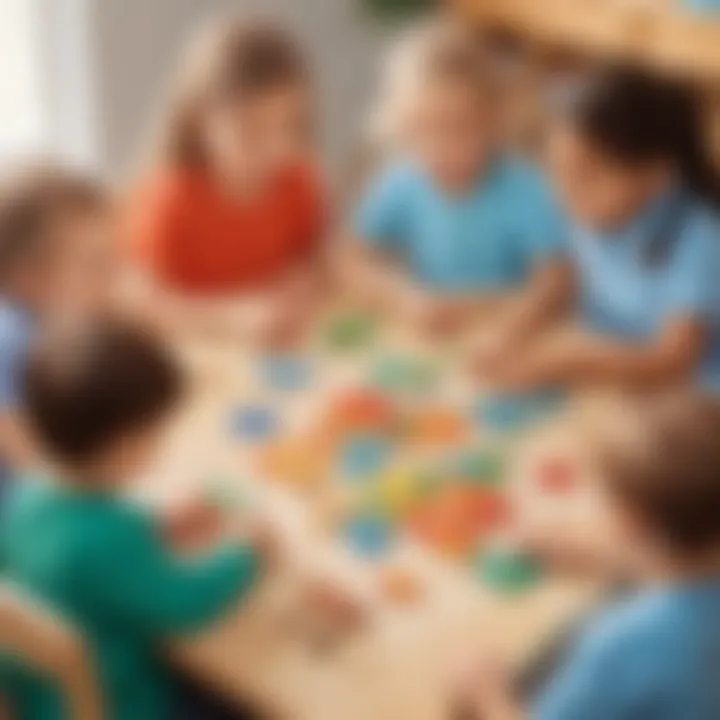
[{"x1": 375, "y1": 22, "x2": 495, "y2": 191}]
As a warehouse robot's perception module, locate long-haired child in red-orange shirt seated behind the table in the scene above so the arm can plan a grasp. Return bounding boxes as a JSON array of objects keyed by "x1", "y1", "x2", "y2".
[{"x1": 130, "y1": 18, "x2": 325, "y2": 340}]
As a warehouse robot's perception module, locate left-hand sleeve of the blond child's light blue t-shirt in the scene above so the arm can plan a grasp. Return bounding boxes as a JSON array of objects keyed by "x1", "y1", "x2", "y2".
[{"x1": 354, "y1": 167, "x2": 410, "y2": 252}]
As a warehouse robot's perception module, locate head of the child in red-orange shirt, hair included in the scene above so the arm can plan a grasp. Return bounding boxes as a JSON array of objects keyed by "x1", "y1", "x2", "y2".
[{"x1": 163, "y1": 18, "x2": 312, "y2": 182}]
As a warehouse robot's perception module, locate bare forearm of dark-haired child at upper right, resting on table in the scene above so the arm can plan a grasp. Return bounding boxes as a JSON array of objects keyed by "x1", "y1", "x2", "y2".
[{"x1": 489, "y1": 318, "x2": 706, "y2": 389}]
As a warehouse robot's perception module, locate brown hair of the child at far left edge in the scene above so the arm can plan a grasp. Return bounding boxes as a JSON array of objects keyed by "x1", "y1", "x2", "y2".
[{"x1": 0, "y1": 165, "x2": 107, "y2": 286}]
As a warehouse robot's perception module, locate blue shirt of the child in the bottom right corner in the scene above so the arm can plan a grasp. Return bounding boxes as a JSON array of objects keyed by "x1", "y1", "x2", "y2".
[{"x1": 532, "y1": 578, "x2": 720, "y2": 720}]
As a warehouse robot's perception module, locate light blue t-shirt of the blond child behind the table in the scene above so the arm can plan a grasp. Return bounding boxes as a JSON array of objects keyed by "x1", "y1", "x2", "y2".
[{"x1": 355, "y1": 157, "x2": 564, "y2": 292}]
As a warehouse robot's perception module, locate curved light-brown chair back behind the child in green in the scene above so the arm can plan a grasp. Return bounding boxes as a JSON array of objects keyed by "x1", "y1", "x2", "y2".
[{"x1": 0, "y1": 588, "x2": 103, "y2": 720}]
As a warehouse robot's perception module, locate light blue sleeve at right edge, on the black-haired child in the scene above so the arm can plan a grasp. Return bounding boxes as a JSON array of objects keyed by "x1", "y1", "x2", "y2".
[{"x1": 666, "y1": 208, "x2": 720, "y2": 320}]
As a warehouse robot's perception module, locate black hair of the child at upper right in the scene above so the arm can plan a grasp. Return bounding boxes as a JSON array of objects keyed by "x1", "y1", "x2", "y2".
[{"x1": 567, "y1": 67, "x2": 720, "y2": 205}]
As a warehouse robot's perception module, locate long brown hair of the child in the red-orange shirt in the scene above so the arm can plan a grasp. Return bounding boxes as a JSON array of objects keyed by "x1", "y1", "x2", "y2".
[{"x1": 160, "y1": 18, "x2": 309, "y2": 166}]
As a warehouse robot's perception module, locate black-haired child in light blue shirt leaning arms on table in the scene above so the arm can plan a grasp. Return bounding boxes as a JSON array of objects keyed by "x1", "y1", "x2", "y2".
[{"x1": 479, "y1": 68, "x2": 720, "y2": 390}]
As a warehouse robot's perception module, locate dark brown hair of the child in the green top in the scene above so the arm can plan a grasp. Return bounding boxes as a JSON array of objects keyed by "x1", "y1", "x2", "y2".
[{"x1": 24, "y1": 321, "x2": 182, "y2": 464}]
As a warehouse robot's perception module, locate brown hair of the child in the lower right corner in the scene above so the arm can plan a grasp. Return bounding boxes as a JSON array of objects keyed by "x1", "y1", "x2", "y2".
[{"x1": 596, "y1": 391, "x2": 720, "y2": 557}]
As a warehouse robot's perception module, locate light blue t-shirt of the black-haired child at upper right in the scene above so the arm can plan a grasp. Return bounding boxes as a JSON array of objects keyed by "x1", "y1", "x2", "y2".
[{"x1": 570, "y1": 190, "x2": 720, "y2": 389}]
